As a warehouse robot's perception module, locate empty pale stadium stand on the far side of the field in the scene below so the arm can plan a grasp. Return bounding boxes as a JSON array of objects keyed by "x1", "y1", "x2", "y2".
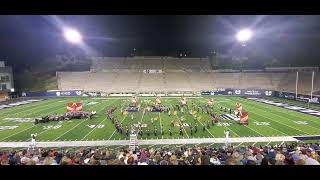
[{"x1": 57, "y1": 57, "x2": 320, "y2": 94}]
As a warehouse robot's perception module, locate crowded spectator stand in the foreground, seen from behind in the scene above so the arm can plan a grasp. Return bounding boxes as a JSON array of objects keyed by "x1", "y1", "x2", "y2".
[{"x1": 0, "y1": 143, "x2": 320, "y2": 165}]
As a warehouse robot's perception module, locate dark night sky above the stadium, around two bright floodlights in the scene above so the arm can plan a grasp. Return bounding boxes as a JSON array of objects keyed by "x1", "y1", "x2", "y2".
[{"x1": 0, "y1": 15, "x2": 320, "y2": 69}]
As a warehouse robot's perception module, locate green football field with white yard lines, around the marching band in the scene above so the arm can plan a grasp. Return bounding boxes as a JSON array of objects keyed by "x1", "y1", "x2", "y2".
[{"x1": 0, "y1": 96, "x2": 320, "y2": 142}]
